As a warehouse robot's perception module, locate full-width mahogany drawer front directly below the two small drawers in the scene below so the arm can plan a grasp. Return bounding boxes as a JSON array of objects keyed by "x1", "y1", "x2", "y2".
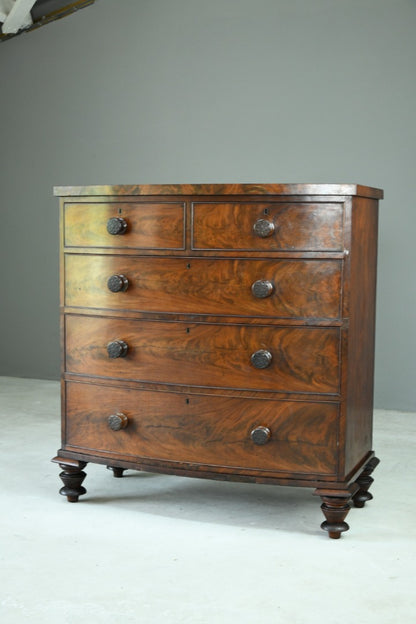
[{"x1": 65, "y1": 254, "x2": 341, "y2": 318}]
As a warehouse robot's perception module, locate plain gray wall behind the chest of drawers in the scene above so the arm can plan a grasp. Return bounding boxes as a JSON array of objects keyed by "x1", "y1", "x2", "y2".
[{"x1": 0, "y1": 0, "x2": 416, "y2": 410}]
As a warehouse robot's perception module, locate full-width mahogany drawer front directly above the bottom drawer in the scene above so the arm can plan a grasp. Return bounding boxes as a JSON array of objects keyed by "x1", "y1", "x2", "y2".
[{"x1": 66, "y1": 315, "x2": 340, "y2": 393}]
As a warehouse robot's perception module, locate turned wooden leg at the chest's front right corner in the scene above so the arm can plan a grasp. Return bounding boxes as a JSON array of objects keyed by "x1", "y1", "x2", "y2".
[{"x1": 314, "y1": 483, "x2": 358, "y2": 539}]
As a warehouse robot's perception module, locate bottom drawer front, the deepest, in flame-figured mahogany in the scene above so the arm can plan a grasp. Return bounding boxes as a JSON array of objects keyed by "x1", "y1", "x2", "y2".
[{"x1": 66, "y1": 383, "x2": 338, "y2": 474}]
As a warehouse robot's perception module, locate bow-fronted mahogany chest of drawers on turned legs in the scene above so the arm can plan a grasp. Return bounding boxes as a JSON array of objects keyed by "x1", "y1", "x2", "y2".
[{"x1": 53, "y1": 184, "x2": 382, "y2": 538}]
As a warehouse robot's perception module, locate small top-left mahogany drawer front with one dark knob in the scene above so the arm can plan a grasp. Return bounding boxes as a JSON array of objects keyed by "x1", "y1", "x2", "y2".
[{"x1": 64, "y1": 202, "x2": 185, "y2": 249}]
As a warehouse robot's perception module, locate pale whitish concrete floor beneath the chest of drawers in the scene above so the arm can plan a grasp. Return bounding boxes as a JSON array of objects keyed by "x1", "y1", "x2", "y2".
[{"x1": 0, "y1": 377, "x2": 416, "y2": 624}]
